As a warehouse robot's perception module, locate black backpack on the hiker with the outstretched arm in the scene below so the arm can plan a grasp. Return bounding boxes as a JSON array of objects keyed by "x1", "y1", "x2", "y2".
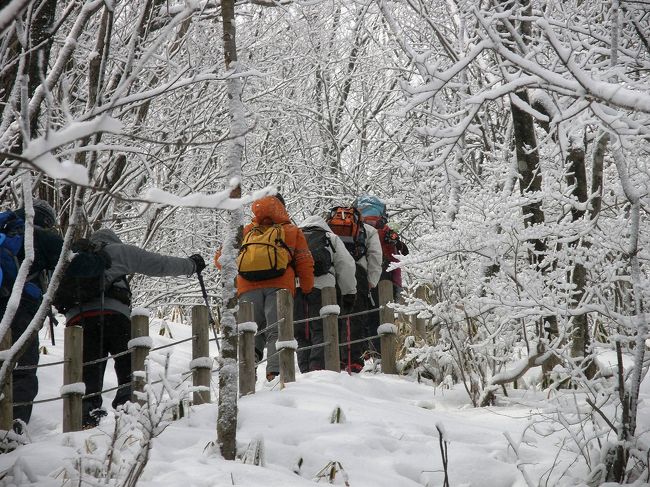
[{"x1": 52, "y1": 238, "x2": 131, "y2": 313}]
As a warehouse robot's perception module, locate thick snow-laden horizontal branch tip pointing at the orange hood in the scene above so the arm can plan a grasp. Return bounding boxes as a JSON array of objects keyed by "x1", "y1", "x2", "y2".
[{"x1": 142, "y1": 179, "x2": 277, "y2": 210}]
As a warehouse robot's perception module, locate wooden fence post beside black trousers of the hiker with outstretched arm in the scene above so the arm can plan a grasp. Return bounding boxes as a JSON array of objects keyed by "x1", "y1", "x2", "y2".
[{"x1": 61, "y1": 326, "x2": 85, "y2": 433}]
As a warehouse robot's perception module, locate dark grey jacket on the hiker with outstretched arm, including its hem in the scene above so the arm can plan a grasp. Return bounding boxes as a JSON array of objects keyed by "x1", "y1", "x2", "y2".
[{"x1": 65, "y1": 228, "x2": 195, "y2": 321}]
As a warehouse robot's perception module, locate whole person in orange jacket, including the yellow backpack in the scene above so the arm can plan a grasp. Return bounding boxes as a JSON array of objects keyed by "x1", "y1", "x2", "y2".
[{"x1": 214, "y1": 194, "x2": 314, "y2": 381}]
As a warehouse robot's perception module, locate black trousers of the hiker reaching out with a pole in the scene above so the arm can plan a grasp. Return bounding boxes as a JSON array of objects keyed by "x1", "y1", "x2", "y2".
[{"x1": 78, "y1": 313, "x2": 131, "y2": 424}]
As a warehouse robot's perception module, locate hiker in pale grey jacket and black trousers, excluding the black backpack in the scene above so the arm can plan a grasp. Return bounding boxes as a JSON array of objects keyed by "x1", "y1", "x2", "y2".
[{"x1": 294, "y1": 216, "x2": 357, "y2": 373}]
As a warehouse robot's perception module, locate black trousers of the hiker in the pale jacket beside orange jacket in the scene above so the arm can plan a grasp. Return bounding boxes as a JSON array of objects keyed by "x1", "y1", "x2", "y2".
[{"x1": 293, "y1": 288, "x2": 325, "y2": 373}]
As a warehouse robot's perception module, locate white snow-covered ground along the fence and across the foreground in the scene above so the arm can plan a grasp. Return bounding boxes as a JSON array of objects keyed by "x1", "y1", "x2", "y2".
[{"x1": 0, "y1": 320, "x2": 650, "y2": 487}]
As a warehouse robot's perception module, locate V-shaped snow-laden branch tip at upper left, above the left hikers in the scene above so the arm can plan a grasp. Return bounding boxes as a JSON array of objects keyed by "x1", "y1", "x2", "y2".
[{"x1": 22, "y1": 116, "x2": 123, "y2": 186}]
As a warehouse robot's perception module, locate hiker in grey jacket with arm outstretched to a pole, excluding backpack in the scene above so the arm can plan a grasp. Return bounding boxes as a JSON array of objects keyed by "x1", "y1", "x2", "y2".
[{"x1": 66, "y1": 228, "x2": 205, "y2": 428}]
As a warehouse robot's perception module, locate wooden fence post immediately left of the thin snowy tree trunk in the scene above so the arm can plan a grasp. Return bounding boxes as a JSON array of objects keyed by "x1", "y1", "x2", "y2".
[{"x1": 190, "y1": 305, "x2": 212, "y2": 404}]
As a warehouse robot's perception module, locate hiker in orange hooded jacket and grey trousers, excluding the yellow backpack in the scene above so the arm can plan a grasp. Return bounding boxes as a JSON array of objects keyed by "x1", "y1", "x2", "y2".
[{"x1": 214, "y1": 194, "x2": 314, "y2": 380}]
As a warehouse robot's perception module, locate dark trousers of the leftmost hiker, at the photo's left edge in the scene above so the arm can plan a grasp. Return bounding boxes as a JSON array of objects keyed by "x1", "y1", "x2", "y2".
[{"x1": 0, "y1": 298, "x2": 39, "y2": 423}]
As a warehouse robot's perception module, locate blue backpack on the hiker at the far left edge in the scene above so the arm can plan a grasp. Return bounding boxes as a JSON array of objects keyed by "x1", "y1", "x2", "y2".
[{"x1": 0, "y1": 211, "x2": 42, "y2": 299}]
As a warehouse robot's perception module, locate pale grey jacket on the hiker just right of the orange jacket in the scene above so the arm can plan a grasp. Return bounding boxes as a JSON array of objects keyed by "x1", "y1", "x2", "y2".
[{"x1": 299, "y1": 216, "x2": 357, "y2": 294}]
